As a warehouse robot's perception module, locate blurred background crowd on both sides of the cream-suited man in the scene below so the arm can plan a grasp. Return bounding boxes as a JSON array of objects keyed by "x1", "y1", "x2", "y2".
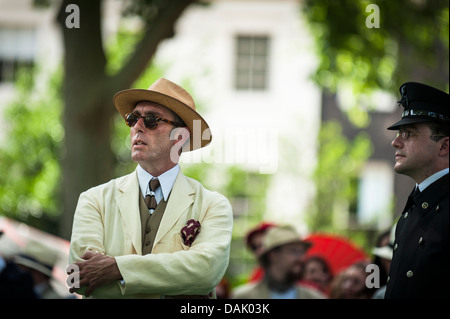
[{"x1": 0, "y1": 218, "x2": 393, "y2": 299}]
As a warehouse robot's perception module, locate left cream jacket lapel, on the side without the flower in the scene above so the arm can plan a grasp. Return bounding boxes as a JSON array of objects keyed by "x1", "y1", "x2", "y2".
[{"x1": 116, "y1": 170, "x2": 142, "y2": 254}]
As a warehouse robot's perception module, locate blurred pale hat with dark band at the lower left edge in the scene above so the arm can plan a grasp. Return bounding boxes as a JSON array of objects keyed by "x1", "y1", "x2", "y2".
[{"x1": 14, "y1": 240, "x2": 58, "y2": 277}]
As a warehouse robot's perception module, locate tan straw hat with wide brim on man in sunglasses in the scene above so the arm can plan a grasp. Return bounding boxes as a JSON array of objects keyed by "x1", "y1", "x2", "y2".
[{"x1": 113, "y1": 78, "x2": 212, "y2": 151}]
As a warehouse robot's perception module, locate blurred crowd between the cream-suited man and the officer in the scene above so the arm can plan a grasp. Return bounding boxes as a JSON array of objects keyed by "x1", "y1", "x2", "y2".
[{"x1": 216, "y1": 222, "x2": 393, "y2": 299}]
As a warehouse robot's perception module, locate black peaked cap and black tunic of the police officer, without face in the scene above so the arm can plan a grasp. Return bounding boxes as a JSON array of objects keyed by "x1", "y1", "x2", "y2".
[{"x1": 385, "y1": 82, "x2": 450, "y2": 299}]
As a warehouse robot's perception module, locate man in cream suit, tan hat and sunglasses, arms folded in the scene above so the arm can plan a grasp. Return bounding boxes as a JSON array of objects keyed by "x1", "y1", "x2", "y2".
[{"x1": 67, "y1": 79, "x2": 233, "y2": 298}]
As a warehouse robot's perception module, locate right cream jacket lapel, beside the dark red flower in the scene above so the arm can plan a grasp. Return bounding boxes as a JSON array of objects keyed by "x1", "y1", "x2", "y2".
[{"x1": 153, "y1": 171, "x2": 195, "y2": 247}]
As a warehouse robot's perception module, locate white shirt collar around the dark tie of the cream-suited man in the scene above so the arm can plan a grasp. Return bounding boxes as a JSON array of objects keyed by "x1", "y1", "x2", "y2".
[{"x1": 136, "y1": 164, "x2": 180, "y2": 202}]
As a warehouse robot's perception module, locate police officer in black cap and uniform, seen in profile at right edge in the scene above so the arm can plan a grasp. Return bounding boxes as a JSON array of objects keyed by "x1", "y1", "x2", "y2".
[{"x1": 385, "y1": 82, "x2": 450, "y2": 299}]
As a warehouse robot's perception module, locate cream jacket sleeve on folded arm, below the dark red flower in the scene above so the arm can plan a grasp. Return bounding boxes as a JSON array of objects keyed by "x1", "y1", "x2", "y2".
[{"x1": 116, "y1": 200, "x2": 232, "y2": 295}]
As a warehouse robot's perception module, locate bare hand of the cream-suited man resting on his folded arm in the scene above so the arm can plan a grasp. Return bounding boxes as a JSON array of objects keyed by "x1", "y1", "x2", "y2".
[{"x1": 67, "y1": 251, "x2": 122, "y2": 297}]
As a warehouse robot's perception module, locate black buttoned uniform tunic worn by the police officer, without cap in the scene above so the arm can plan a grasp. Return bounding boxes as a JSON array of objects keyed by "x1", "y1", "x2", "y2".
[{"x1": 385, "y1": 174, "x2": 450, "y2": 298}]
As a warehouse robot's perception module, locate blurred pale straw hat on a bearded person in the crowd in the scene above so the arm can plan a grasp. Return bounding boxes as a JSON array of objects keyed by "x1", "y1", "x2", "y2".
[{"x1": 261, "y1": 225, "x2": 312, "y2": 258}]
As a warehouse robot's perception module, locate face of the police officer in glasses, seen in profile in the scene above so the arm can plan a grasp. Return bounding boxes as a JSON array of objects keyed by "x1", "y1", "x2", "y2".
[{"x1": 391, "y1": 123, "x2": 442, "y2": 183}]
